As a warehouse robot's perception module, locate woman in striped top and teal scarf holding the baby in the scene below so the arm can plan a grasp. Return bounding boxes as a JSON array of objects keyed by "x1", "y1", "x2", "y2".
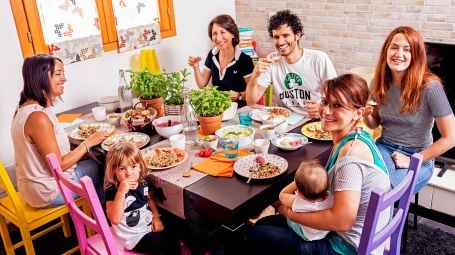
[{"x1": 246, "y1": 74, "x2": 390, "y2": 255}]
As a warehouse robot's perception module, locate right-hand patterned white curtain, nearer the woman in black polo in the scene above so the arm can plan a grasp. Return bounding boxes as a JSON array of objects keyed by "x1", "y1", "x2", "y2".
[{"x1": 112, "y1": 0, "x2": 160, "y2": 52}]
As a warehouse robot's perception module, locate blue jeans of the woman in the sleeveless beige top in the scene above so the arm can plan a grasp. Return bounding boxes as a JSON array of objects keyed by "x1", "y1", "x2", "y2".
[{"x1": 49, "y1": 159, "x2": 104, "y2": 207}]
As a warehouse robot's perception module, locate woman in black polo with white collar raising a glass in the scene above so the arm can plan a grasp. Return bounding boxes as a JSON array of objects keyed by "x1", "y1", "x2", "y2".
[{"x1": 188, "y1": 14, "x2": 254, "y2": 101}]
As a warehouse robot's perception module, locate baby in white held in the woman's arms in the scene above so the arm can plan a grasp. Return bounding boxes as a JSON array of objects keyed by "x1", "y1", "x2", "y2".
[{"x1": 280, "y1": 160, "x2": 333, "y2": 241}]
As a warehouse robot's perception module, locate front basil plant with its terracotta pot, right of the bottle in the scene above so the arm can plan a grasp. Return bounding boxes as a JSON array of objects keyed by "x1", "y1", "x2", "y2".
[{"x1": 190, "y1": 86, "x2": 231, "y2": 135}]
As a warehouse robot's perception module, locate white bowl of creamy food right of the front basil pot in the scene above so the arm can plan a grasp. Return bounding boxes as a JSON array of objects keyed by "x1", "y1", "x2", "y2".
[{"x1": 215, "y1": 125, "x2": 255, "y2": 147}]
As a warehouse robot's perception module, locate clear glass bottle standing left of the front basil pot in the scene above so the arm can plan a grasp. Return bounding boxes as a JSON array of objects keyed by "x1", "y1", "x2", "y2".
[{"x1": 182, "y1": 88, "x2": 198, "y2": 143}]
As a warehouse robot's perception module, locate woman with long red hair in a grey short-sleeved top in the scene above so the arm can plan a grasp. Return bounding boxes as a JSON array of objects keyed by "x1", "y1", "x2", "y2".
[{"x1": 364, "y1": 27, "x2": 455, "y2": 193}]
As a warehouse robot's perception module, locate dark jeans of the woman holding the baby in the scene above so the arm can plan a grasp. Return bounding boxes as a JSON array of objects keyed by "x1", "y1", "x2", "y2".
[{"x1": 245, "y1": 215, "x2": 336, "y2": 255}]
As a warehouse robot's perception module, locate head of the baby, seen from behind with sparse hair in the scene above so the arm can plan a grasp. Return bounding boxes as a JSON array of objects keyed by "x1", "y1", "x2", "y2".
[{"x1": 294, "y1": 160, "x2": 329, "y2": 201}]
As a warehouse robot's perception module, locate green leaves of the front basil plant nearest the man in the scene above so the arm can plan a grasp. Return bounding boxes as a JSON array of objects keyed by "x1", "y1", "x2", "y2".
[{"x1": 190, "y1": 86, "x2": 231, "y2": 117}]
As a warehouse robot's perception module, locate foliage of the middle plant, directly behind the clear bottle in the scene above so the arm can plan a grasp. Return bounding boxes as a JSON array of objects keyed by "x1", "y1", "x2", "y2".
[{"x1": 164, "y1": 68, "x2": 191, "y2": 105}]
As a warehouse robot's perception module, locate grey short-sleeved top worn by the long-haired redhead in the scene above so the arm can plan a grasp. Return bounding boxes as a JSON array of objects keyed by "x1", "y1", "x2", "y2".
[{"x1": 379, "y1": 80, "x2": 452, "y2": 147}]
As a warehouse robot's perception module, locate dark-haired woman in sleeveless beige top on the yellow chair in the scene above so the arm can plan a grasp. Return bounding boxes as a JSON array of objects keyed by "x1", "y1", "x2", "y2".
[{"x1": 11, "y1": 54, "x2": 107, "y2": 208}]
